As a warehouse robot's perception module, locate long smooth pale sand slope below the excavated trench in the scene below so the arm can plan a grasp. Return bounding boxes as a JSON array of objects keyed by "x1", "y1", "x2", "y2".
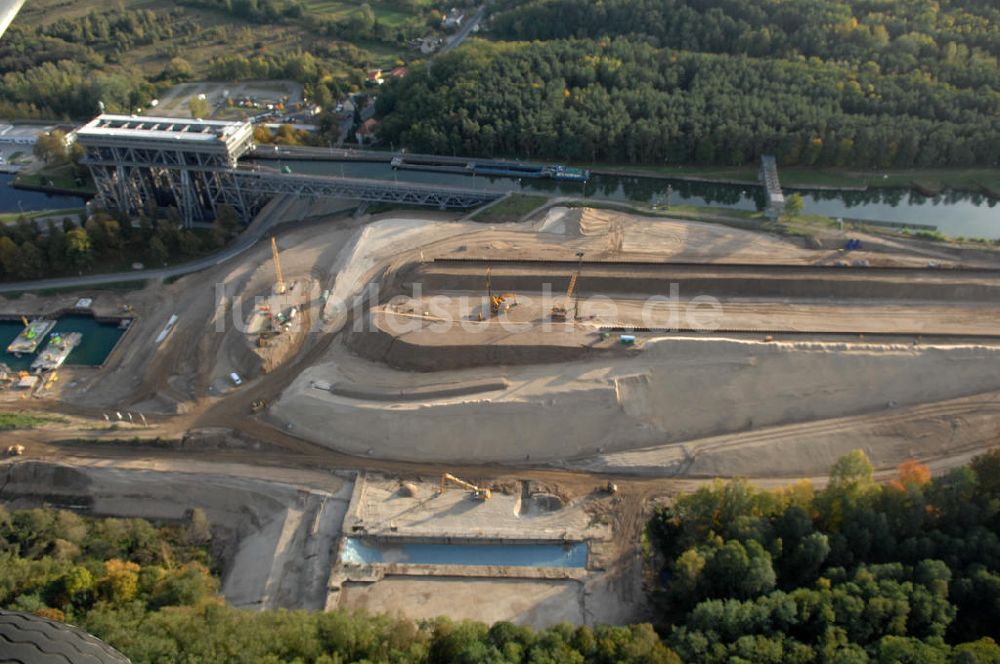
[{"x1": 273, "y1": 337, "x2": 1000, "y2": 462}]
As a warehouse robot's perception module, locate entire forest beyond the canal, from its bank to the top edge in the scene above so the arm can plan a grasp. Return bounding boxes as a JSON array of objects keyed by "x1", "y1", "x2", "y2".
[{"x1": 379, "y1": 0, "x2": 1000, "y2": 169}]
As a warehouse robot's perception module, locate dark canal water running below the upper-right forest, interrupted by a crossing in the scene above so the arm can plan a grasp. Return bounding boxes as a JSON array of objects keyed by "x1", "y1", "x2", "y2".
[{"x1": 268, "y1": 160, "x2": 1000, "y2": 239}]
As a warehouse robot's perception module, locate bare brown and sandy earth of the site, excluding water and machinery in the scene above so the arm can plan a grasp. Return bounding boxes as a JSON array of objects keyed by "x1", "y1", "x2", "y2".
[{"x1": 0, "y1": 208, "x2": 1000, "y2": 625}]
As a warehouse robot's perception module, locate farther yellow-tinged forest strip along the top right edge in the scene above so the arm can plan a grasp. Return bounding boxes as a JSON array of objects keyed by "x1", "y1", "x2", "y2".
[{"x1": 492, "y1": 0, "x2": 1000, "y2": 90}]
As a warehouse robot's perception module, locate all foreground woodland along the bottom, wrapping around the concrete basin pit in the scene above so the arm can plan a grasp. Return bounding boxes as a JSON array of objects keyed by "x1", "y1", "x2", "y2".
[{"x1": 0, "y1": 450, "x2": 1000, "y2": 664}]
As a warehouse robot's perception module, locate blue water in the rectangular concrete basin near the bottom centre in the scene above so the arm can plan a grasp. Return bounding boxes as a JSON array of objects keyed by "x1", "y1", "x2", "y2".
[{"x1": 340, "y1": 537, "x2": 587, "y2": 568}]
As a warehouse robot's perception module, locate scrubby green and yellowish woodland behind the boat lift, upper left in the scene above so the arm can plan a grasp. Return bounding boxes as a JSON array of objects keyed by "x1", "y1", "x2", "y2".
[{"x1": 0, "y1": 0, "x2": 426, "y2": 120}]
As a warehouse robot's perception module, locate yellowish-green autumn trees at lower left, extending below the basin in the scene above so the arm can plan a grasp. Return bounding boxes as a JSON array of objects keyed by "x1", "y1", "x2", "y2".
[{"x1": 0, "y1": 505, "x2": 679, "y2": 664}]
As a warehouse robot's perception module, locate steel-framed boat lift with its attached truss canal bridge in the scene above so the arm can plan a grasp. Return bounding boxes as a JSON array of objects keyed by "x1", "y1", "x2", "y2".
[{"x1": 76, "y1": 115, "x2": 504, "y2": 226}]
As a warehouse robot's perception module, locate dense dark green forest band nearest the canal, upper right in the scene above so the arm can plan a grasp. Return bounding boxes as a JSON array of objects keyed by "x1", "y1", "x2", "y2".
[{"x1": 378, "y1": 38, "x2": 1000, "y2": 168}]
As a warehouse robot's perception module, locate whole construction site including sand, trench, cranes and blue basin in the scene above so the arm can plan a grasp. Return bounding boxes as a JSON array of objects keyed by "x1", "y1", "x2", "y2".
[{"x1": 0, "y1": 199, "x2": 1000, "y2": 625}]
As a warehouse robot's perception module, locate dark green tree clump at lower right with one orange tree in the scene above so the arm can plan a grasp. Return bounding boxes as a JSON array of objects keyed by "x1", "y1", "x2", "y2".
[{"x1": 649, "y1": 451, "x2": 1000, "y2": 664}]
